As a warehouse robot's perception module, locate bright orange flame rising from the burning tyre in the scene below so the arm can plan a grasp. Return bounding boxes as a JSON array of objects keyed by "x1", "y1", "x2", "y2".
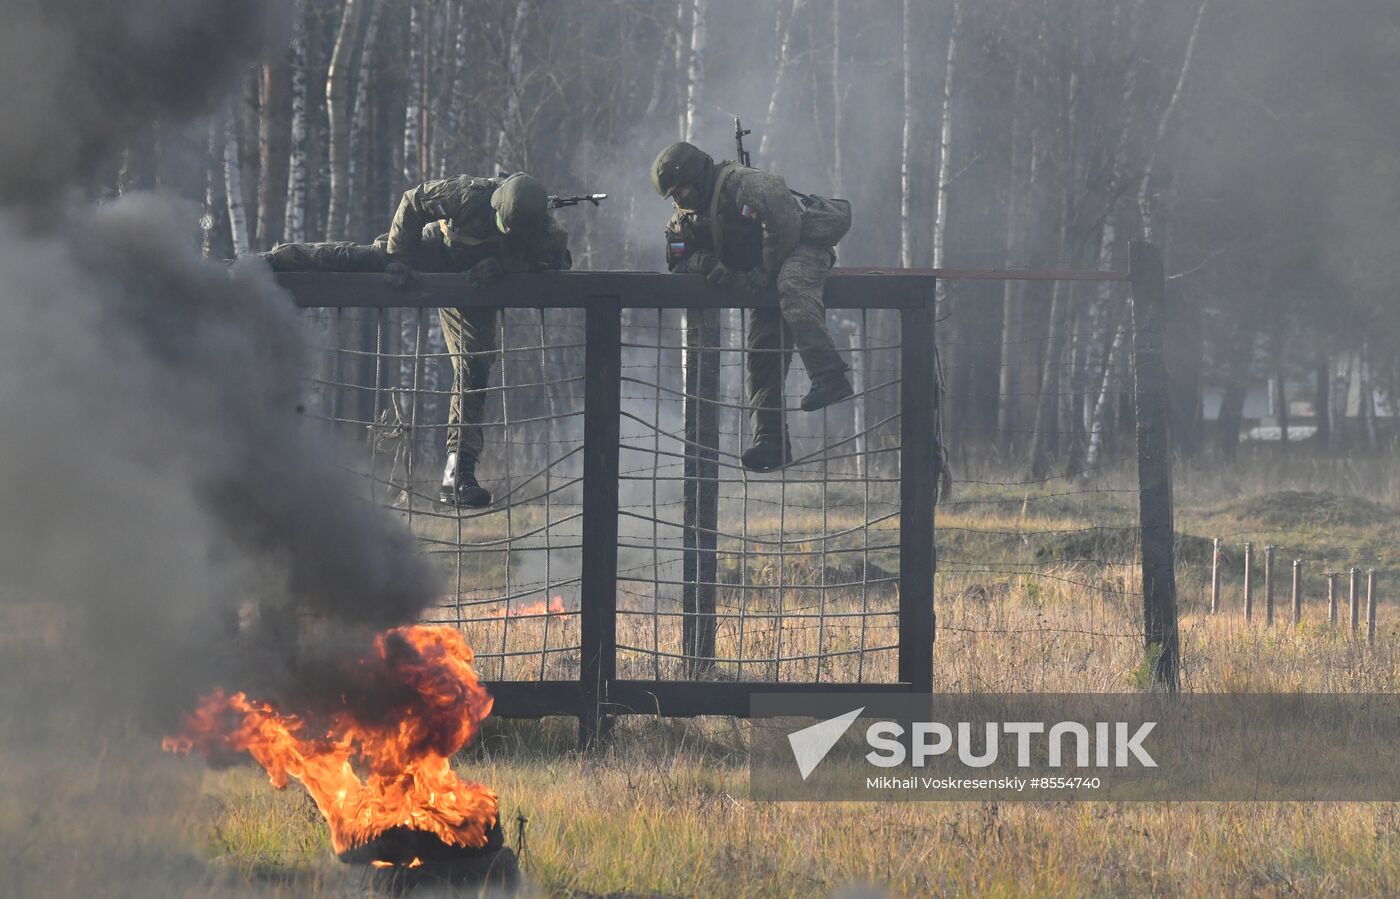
[{"x1": 162, "y1": 626, "x2": 497, "y2": 851}]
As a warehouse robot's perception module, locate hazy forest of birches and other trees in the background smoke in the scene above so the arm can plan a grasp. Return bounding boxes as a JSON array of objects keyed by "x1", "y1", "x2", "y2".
[{"x1": 101, "y1": 0, "x2": 1400, "y2": 475}]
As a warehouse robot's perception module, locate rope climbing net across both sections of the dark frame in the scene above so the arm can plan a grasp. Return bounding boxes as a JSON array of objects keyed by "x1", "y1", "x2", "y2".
[{"x1": 307, "y1": 308, "x2": 900, "y2": 682}]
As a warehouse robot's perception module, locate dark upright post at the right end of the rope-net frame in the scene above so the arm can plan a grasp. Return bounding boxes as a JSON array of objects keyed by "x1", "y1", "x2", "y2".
[{"x1": 899, "y1": 290, "x2": 938, "y2": 690}]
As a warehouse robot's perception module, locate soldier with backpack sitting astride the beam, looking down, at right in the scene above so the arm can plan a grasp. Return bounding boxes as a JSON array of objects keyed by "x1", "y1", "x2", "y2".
[{"x1": 651, "y1": 143, "x2": 853, "y2": 472}]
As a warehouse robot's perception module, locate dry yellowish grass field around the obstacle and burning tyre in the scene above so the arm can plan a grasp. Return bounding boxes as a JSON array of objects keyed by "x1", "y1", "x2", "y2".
[{"x1": 0, "y1": 459, "x2": 1400, "y2": 896}]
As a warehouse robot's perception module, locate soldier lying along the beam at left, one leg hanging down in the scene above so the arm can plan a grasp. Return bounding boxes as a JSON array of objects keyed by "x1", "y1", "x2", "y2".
[{"x1": 269, "y1": 172, "x2": 573, "y2": 507}]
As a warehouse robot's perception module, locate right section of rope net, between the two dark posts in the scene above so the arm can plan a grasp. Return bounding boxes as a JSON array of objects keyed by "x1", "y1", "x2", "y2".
[{"x1": 617, "y1": 309, "x2": 899, "y2": 682}]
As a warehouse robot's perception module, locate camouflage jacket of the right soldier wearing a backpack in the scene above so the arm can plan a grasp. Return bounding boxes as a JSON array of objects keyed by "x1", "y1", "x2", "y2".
[{"x1": 666, "y1": 162, "x2": 802, "y2": 281}]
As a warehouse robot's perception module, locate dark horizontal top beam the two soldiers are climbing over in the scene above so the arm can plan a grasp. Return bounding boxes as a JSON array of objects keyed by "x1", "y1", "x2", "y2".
[{"x1": 276, "y1": 272, "x2": 934, "y2": 309}]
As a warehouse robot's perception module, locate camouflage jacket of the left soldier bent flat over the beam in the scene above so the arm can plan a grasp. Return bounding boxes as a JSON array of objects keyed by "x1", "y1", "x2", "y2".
[{"x1": 388, "y1": 175, "x2": 573, "y2": 272}]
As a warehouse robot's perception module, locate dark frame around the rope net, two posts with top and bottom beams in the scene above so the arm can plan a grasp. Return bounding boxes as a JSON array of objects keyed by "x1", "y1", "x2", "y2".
[{"x1": 277, "y1": 272, "x2": 938, "y2": 742}]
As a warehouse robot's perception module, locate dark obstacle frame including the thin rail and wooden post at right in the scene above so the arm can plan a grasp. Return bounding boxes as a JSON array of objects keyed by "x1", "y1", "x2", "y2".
[{"x1": 277, "y1": 244, "x2": 1177, "y2": 744}]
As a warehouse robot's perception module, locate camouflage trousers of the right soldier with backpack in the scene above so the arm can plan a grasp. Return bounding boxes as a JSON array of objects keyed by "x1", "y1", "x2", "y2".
[{"x1": 745, "y1": 244, "x2": 850, "y2": 440}]
